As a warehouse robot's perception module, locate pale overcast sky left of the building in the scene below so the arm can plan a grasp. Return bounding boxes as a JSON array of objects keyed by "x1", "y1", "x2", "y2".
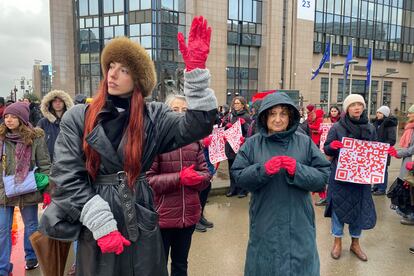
[{"x1": 0, "y1": 0, "x2": 51, "y2": 97}]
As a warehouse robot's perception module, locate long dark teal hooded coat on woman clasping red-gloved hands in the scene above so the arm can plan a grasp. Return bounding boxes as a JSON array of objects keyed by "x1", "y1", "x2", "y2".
[{"x1": 231, "y1": 92, "x2": 329, "y2": 276}]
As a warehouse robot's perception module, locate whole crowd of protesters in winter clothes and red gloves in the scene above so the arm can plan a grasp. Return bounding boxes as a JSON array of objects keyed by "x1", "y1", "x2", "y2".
[{"x1": 0, "y1": 17, "x2": 414, "y2": 276}]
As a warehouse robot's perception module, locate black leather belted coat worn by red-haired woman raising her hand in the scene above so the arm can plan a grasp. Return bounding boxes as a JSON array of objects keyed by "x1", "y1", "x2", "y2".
[{"x1": 41, "y1": 103, "x2": 217, "y2": 276}]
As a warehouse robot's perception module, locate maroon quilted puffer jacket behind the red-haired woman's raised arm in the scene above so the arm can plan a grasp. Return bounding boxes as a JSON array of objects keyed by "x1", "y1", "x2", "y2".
[{"x1": 147, "y1": 142, "x2": 211, "y2": 228}]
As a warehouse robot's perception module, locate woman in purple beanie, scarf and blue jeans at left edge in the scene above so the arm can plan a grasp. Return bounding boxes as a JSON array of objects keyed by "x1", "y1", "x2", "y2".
[{"x1": 0, "y1": 102, "x2": 50, "y2": 275}]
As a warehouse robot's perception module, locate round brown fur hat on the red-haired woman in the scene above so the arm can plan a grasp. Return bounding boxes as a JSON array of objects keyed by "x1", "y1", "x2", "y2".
[{"x1": 101, "y1": 37, "x2": 157, "y2": 97}]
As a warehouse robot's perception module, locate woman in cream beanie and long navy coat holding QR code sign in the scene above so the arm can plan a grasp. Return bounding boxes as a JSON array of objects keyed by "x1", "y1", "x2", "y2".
[{"x1": 324, "y1": 94, "x2": 377, "y2": 261}]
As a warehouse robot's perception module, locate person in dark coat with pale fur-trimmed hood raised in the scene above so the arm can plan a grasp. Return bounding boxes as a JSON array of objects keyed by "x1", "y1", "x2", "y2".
[{"x1": 37, "y1": 90, "x2": 73, "y2": 162}]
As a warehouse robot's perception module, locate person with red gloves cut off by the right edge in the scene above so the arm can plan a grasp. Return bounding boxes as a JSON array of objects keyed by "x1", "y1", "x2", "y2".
[{"x1": 389, "y1": 105, "x2": 414, "y2": 225}]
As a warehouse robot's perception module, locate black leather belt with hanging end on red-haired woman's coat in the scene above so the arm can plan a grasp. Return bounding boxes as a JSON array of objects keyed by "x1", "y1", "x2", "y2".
[{"x1": 93, "y1": 171, "x2": 145, "y2": 242}]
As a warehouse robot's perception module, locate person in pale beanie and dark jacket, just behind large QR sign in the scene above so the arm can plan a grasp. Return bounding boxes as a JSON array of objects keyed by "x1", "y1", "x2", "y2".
[{"x1": 372, "y1": 105, "x2": 398, "y2": 195}]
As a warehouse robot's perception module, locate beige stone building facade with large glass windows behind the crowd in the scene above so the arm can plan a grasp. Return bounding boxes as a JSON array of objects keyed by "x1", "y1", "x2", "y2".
[{"x1": 50, "y1": 0, "x2": 414, "y2": 112}]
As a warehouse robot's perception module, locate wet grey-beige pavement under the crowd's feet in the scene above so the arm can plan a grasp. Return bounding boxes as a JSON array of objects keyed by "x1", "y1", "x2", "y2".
[{"x1": 8, "y1": 156, "x2": 414, "y2": 276}]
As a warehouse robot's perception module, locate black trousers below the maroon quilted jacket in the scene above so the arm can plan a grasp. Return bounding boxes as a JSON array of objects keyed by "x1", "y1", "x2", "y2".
[{"x1": 161, "y1": 225, "x2": 195, "y2": 276}]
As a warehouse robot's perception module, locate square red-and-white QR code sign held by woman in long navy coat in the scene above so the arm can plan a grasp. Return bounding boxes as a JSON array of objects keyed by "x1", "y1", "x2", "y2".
[{"x1": 335, "y1": 137, "x2": 390, "y2": 184}]
